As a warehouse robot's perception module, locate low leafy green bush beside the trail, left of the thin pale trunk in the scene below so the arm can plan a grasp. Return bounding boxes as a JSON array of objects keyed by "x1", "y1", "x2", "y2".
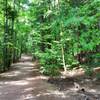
[{"x1": 40, "y1": 50, "x2": 60, "y2": 76}]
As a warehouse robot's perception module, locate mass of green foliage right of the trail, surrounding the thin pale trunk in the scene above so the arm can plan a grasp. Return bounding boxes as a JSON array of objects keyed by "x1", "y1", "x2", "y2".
[{"x1": 30, "y1": 0, "x2": 100, "y2": 74}]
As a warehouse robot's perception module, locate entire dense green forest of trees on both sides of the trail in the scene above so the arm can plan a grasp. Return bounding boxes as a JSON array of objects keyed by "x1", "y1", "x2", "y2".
[{"x1": 0, "y1": 0, "x2": 100, "y2": 75}]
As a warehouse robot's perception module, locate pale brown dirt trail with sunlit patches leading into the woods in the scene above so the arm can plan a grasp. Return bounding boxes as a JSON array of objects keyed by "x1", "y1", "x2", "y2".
[{"x1": 0, "y1": 55, "x2": 100, "y2": 100}]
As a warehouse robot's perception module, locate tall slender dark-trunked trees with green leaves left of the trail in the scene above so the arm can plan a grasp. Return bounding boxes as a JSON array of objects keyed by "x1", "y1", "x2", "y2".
[{"x1": 0, "y1": 0, "x2": 29, "y2": 71}]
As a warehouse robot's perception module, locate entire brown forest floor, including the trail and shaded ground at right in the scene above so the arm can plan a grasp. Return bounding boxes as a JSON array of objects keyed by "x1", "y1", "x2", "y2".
[{"x1": 0, "y1": 55, "x2": 100, "y2": 100}]
